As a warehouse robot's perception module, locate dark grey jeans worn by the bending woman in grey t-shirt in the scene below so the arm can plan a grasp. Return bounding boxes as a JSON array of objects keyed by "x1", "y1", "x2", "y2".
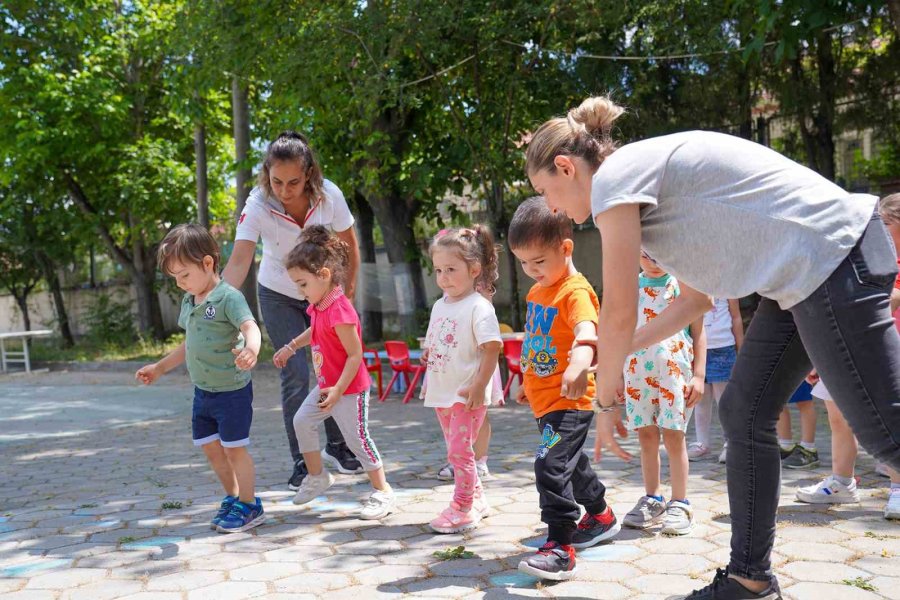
[{"x1": 719, "y1": 215, "x2": 900, "y2": 580}]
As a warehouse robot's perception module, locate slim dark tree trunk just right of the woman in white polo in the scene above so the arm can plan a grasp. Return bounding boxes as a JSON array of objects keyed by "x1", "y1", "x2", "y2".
[{"x1": 353, "y1": 191, "x2": 384, "y2": 342}]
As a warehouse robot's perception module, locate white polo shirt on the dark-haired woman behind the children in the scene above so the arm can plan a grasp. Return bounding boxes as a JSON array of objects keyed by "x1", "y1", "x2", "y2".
[{"x1": 234, "y1": 179, "x2": 354, "y2": 300}]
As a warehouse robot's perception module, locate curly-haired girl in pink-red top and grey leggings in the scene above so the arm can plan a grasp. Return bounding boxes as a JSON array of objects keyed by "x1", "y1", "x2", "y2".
[{"x1": 273, "y1": 225, "x2": 394, "y2": 520}]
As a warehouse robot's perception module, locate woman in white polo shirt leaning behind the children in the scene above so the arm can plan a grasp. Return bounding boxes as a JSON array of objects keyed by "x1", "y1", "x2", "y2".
[{"x1": 222, "y1": 131, "x2": 362, "y2": 490}]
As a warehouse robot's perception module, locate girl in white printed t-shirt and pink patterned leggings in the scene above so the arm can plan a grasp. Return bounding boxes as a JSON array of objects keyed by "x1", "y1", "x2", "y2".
[{"x1": 424, "y1": 225, "x2": 501, "y2": 533}]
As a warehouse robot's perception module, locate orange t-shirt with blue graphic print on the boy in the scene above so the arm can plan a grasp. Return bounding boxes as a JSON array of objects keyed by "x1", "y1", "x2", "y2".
[{"x1": 522, "y1": 273, "x2": 600, "y2": 418}]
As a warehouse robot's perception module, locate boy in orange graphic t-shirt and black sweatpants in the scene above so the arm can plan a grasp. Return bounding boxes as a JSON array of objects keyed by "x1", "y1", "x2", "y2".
[{"x1": 509, "y1": 198, "x2": 621, "y2": 581}]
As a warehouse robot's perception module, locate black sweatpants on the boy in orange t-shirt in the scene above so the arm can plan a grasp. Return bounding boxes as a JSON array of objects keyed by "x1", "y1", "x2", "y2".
[{"x1": 534, "y1": 410, "x2": 606, "y2": 545}]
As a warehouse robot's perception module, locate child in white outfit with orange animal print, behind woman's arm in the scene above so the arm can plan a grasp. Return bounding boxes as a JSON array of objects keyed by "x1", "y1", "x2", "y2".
[{"x1": 624, "y1": 251, "x2": 706, "y2": 535}]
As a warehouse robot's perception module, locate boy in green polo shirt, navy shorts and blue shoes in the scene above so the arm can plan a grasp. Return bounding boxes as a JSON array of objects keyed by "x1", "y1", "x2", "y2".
[{"x1": 135, "y1": 224, "x2": 266, "y2": 533}]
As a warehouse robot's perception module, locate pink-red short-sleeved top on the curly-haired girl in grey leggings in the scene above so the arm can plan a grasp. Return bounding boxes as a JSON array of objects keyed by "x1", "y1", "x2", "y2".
[{"x1": 306, "y1": 287, "x2": 372, "y2": 395}]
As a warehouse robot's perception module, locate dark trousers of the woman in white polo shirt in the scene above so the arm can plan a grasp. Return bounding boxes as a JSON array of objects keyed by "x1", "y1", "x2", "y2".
[{"x1": 259, "y1": 286, "x2": 349, "y2": 463}]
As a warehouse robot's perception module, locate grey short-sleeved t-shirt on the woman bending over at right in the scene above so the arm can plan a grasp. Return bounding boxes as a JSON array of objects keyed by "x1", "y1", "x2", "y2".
[{"x1": 591, "y1": 131, "x2": 877, "y2": 309}]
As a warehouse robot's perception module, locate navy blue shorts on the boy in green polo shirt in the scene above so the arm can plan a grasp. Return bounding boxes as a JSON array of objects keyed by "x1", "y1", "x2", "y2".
[{"x1": 191, "y1": 382, "x2": 253, "y2": 448}]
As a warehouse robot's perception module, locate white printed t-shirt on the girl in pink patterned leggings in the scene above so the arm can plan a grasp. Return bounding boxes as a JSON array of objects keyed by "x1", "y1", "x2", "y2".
[{"x1": 424, "y1": 292, "x2": 502, "y2": 408}]
